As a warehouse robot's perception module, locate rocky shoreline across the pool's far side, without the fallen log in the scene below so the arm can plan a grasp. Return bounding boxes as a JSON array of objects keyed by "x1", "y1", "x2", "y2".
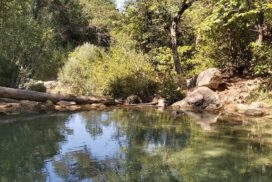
[{"x1": 0, "y1": 68, "x2": 272, "y2": 120}]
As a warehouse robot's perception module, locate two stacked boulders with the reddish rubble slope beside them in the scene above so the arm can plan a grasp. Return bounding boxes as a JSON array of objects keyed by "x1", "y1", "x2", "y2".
[{"x1": 172, "y1": 68, "x2": 269, "y2": 117}]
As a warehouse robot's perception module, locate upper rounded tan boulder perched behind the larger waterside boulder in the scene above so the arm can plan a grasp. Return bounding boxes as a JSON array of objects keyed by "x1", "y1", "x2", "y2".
[{"x1": 196, "y1": 68, "x2": 222, "y2": 90}]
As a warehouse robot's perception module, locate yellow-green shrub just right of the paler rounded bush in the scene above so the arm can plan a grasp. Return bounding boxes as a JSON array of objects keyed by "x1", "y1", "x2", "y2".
[{"x1": 91, "y1": 35, "x2": 156, "y2": 100}]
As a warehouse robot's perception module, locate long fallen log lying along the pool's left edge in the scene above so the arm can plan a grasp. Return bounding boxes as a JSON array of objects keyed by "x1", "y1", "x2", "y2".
[{"x1": 0, "y1": 87, "x2": 117, "y2": 105}]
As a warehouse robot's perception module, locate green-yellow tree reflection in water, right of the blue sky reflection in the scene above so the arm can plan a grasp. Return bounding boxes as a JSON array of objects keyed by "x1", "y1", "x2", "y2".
[{"x1": 75, "y1": 109, "x2": 272, "y2": 181}]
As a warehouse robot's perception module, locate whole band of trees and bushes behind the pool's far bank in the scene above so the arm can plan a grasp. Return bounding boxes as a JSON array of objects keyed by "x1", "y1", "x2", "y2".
[{"x1": 0, "y1": 0, "x2": 272, "y2": 97}]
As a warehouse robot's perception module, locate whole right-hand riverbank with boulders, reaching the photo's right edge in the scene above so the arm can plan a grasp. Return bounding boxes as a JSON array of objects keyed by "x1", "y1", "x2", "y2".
[{"x1": 172, "y1": 68, "x2": 272, "y2": 118}]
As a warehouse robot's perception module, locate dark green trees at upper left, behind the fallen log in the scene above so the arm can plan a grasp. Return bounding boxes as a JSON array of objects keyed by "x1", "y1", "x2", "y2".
[{"x1": 0, "y1": 0, "x2": 114, "y2": 87}]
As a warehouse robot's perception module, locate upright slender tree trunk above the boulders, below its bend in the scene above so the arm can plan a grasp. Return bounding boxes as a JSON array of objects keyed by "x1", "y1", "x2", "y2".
[{"x1": 170, "y1": 19, "x2": 182, "y2": 74}]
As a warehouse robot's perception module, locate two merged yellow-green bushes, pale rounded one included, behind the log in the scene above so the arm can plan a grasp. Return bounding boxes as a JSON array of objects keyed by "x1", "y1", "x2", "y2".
[{"x1": 59, "y1": 35, "x2": 158, "y2": 100}]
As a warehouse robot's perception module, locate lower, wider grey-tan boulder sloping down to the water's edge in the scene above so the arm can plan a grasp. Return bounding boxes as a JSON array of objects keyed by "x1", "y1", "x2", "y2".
[{"x1": 172, "y1": 87, "x2": 221, "y2": 112}]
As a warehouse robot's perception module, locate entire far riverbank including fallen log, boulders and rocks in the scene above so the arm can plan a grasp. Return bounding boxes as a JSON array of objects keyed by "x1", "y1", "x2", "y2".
[{"x1": 0, "y1": 68, "x2": 272, "y2": 121}]
